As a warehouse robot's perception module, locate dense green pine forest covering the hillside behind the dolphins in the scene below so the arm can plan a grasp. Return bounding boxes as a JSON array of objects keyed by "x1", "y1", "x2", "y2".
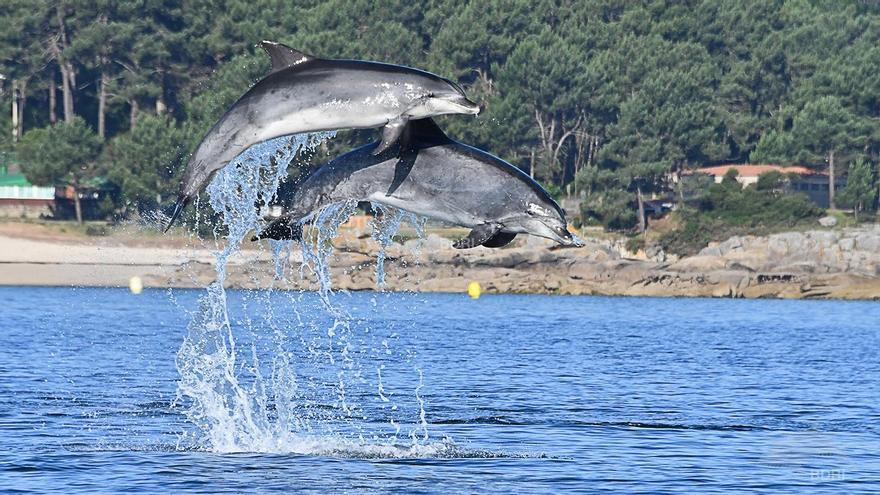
[{"x1": 0, "y1": 0, "x2": 880, "y2": 231}]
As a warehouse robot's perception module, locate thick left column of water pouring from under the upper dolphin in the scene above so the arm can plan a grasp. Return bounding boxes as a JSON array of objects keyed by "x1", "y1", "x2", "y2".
[{"x1": 177, "y1": 132, "x2": 333, "y2": 452}]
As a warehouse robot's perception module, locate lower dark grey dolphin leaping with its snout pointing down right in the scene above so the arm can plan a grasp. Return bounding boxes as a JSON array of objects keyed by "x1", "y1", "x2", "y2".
[{"x1": 253, "y1": 118, "x2": 582, "y2": 249}]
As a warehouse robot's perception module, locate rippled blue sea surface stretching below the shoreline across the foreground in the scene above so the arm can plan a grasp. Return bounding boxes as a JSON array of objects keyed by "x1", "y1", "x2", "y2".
[{"x1": 0, "y1": 288, "x2": 880, "y2": 493}]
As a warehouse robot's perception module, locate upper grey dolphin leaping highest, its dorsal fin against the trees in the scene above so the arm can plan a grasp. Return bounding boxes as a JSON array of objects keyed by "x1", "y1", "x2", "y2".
[{"x1": 165, "y1": 41, "x2": 480, "y2": 231}]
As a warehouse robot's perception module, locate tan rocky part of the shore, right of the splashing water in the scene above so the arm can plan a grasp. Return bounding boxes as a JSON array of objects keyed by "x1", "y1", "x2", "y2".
[{"x1": 276, "y1": 228, "x2": 880, "y2": 299}]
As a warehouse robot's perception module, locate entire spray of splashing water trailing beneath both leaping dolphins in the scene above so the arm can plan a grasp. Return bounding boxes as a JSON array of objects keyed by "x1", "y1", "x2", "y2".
[{"x1": 176, "y1": 133, "x2": 440, "y2": 457}]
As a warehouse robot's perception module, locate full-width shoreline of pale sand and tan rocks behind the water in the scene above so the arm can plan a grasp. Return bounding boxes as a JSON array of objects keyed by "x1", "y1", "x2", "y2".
[{"x1": 0, "y1": 226, "x2": 880, "y2": 299}]
